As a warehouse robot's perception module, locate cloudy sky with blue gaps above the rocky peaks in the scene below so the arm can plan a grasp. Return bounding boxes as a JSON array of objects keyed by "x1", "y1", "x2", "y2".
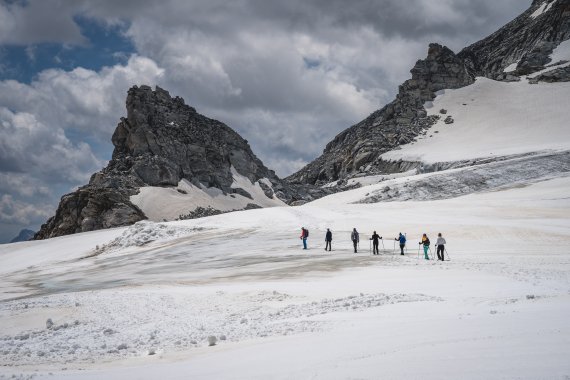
[{"x1": 0, "y1": 0, "x2": 531, "y2": 243}]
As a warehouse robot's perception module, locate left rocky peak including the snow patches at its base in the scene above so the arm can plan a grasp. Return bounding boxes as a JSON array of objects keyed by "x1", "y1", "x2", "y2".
[{"x1": 35, "y1": 86, "x2": 332, "y2": 239}]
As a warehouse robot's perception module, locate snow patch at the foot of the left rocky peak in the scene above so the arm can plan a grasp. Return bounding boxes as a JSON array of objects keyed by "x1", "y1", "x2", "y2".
[{"x1": 130, "y1": 167, "x2": 285, "y2": 222}]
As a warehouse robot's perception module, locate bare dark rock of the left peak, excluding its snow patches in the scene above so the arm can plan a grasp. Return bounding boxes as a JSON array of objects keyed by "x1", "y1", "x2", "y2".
[{"x1": 35, "y1": 86, "x2": 322, "y2": 239}]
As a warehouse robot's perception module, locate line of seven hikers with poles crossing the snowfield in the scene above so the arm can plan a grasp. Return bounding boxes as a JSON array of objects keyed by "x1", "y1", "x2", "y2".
[{"x1": 300, "y1": 227, "x2": 447, "y2": 261}]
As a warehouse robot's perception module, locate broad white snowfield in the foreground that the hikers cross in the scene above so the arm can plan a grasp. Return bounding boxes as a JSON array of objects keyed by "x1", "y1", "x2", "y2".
[{"x1": 0, "y1": 169, "x2": 570, "y2": 379}]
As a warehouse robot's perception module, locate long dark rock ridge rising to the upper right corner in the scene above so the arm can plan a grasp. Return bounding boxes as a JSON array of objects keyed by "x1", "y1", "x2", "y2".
[{"x1": 286, "y1": 0, "x2": 570, "y2": 185}]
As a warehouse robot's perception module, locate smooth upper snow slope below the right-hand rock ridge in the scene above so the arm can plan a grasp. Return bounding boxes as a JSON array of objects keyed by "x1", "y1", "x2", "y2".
[{"x1": 382, "y1": 78, "x2": 570, "y2": 163}]
